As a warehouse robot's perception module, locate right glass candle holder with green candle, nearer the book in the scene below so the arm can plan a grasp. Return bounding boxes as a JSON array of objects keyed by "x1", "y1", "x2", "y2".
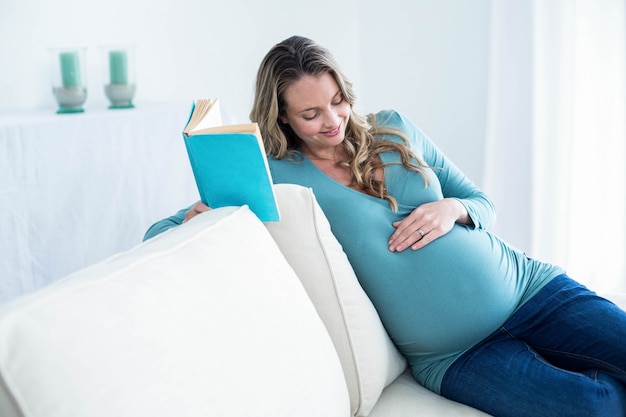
[{"x1": 102, "y1": 45, "x2": 136, "y2": 109}]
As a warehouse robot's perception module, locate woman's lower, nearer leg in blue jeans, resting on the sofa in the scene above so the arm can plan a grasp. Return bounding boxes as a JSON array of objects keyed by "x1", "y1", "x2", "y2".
[{"x1": 441, "y1": 334, "x2": 626, "y2": 417}]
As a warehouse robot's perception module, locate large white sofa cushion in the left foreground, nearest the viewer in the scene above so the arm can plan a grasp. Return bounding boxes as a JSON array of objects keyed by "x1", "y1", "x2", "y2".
[{"x1": 0, "y1": 207, "x2": 350, "y2": 417}]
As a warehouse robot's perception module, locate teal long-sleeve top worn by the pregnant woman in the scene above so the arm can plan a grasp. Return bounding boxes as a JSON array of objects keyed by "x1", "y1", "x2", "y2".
[{"x1": 146, "y1": 111, "x2": 564, "y2": 393}]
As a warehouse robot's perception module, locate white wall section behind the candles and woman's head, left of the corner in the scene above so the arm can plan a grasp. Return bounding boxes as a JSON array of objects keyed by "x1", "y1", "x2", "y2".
[{"x1": 0, "y1": 0, "x2": 358, "y2": 121}]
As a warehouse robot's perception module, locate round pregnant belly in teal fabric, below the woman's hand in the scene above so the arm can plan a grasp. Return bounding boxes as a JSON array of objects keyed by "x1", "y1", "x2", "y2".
[{"x1": 347, "y1": 226, "x2": 522, "y2": 355}]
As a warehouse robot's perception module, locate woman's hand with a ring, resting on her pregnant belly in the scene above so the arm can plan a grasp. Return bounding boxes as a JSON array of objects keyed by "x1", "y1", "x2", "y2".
[{"x1": 389, "y1": 198, "x2": 471, "y2": 252}]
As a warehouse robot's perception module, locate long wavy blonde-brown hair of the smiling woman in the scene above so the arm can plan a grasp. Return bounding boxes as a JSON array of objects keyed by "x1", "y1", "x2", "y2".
[{"x1": 250, "y1": 36, "x2": 428, "y2": 210}]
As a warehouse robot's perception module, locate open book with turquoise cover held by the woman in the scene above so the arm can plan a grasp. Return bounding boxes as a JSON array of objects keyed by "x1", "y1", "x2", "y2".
[{"x1": 183, "y1": 99, "x2": 280, "y2": 222}]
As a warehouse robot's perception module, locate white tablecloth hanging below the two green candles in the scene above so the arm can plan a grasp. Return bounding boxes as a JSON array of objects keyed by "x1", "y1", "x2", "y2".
[{"x1": 0, "y1": 106, "x2": 198, "y2": 302}]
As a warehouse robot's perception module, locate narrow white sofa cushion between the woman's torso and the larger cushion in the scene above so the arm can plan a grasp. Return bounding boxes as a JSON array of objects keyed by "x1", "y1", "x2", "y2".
[{"x1": 266, "y1": 184, "x2": 406, "y2": 416}]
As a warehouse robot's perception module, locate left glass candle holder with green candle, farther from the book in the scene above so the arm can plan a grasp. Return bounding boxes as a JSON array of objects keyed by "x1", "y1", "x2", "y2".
[{"x1": 50, "y1": 48, "x2": 87, "y2": 113}]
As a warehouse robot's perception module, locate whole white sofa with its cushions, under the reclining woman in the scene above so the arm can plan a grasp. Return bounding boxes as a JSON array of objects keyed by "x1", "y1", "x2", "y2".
[{"x1": 0, "y1": 185, "x2": 620, "y2": 417}]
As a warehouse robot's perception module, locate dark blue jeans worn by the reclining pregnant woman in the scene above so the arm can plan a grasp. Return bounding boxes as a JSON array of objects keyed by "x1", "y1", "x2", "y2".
[{"x1": 441, "y1": 275, "x2": 626, "y2": 417}]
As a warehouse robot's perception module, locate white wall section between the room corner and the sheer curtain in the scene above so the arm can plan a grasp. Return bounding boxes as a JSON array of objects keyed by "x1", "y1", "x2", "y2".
[{"x1": 359, "y1": 0, "x2": 491, "y2": 185}]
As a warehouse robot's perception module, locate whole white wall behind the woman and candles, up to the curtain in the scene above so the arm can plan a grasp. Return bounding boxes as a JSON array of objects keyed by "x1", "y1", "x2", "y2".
[{"x1": 0, "y1": 0, "x2": 490, "y2": 183}]
